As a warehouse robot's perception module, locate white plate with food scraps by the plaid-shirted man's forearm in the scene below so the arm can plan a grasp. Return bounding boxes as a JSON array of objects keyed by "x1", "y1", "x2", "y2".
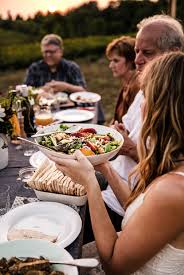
[{"x1": 70, "y1": 92, "x2": 101, "y2": 103}]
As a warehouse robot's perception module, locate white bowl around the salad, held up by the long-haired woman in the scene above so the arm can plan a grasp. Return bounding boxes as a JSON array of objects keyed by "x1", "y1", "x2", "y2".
[{"x1": 35, "y1": 123, "x2": 124, "y2": 165}]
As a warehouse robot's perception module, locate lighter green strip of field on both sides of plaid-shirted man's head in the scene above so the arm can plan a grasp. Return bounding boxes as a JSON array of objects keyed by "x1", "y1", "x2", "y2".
[{"x1": 0, "y1": 36, "x2": 120, "y2": 69}]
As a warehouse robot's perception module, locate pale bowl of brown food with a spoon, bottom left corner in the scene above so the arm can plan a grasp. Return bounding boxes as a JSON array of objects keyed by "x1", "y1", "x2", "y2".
[{"x1": 0, "y1": 240, "x2": 78, "y2": 275}]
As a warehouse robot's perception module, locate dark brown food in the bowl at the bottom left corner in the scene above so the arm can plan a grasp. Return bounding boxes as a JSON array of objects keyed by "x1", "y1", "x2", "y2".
[{"x1": 0, "y1": 255, "x2": 64, "y2": 275}]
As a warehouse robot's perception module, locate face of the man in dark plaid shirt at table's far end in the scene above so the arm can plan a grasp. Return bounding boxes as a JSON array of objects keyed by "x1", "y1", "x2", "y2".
[{"x1": 41, "y1": 44, "x2": 62, "y2": 67}]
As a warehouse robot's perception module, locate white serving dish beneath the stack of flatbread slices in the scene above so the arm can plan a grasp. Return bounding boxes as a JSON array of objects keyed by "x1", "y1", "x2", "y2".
[{"x1": 34, "y1": 189, "x2": 87, "y2": 206}]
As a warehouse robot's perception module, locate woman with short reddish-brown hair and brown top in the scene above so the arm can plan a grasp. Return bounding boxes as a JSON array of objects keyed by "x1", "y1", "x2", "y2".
[{"x1": 106, "y1": 36, "x2": 139, "y2": 124}]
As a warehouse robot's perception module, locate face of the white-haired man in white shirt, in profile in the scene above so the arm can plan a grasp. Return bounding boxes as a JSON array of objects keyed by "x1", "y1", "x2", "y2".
[{"x1": 135, "y1": 26, "x2": 163, "y2": 72}]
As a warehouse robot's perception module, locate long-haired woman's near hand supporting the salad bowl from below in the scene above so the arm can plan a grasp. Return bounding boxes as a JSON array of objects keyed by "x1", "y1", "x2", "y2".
[{"x1": 50, "y1": 150, "x2": 96, "y2": 189}]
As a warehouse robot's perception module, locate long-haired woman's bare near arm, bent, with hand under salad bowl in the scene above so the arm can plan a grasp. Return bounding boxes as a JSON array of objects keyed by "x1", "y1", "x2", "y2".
[{"x1": 49, "y1": 152, "x2": 184, "y2": 275}]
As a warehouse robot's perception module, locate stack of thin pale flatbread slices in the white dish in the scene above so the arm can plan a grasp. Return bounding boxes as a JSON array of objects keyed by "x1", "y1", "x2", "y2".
[{"x1": 27, "y1": 159, "x2": 86, "y2": 196}]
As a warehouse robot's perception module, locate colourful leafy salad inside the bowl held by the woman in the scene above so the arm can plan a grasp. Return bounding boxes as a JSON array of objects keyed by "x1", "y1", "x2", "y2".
[{"x1": 39, "y1": 124, "x2": 120, "y2": 156}]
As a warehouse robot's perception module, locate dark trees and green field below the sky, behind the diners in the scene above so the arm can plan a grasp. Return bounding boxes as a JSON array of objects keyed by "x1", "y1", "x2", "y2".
[{"x1": 0, "y1": 0, "x2": 178, "y2": 70}]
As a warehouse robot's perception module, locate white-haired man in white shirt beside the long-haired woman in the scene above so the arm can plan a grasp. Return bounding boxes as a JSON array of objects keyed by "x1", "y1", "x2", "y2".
[{"x1": 85, "y1": 15, "x2": 184, "y2": 244}]
